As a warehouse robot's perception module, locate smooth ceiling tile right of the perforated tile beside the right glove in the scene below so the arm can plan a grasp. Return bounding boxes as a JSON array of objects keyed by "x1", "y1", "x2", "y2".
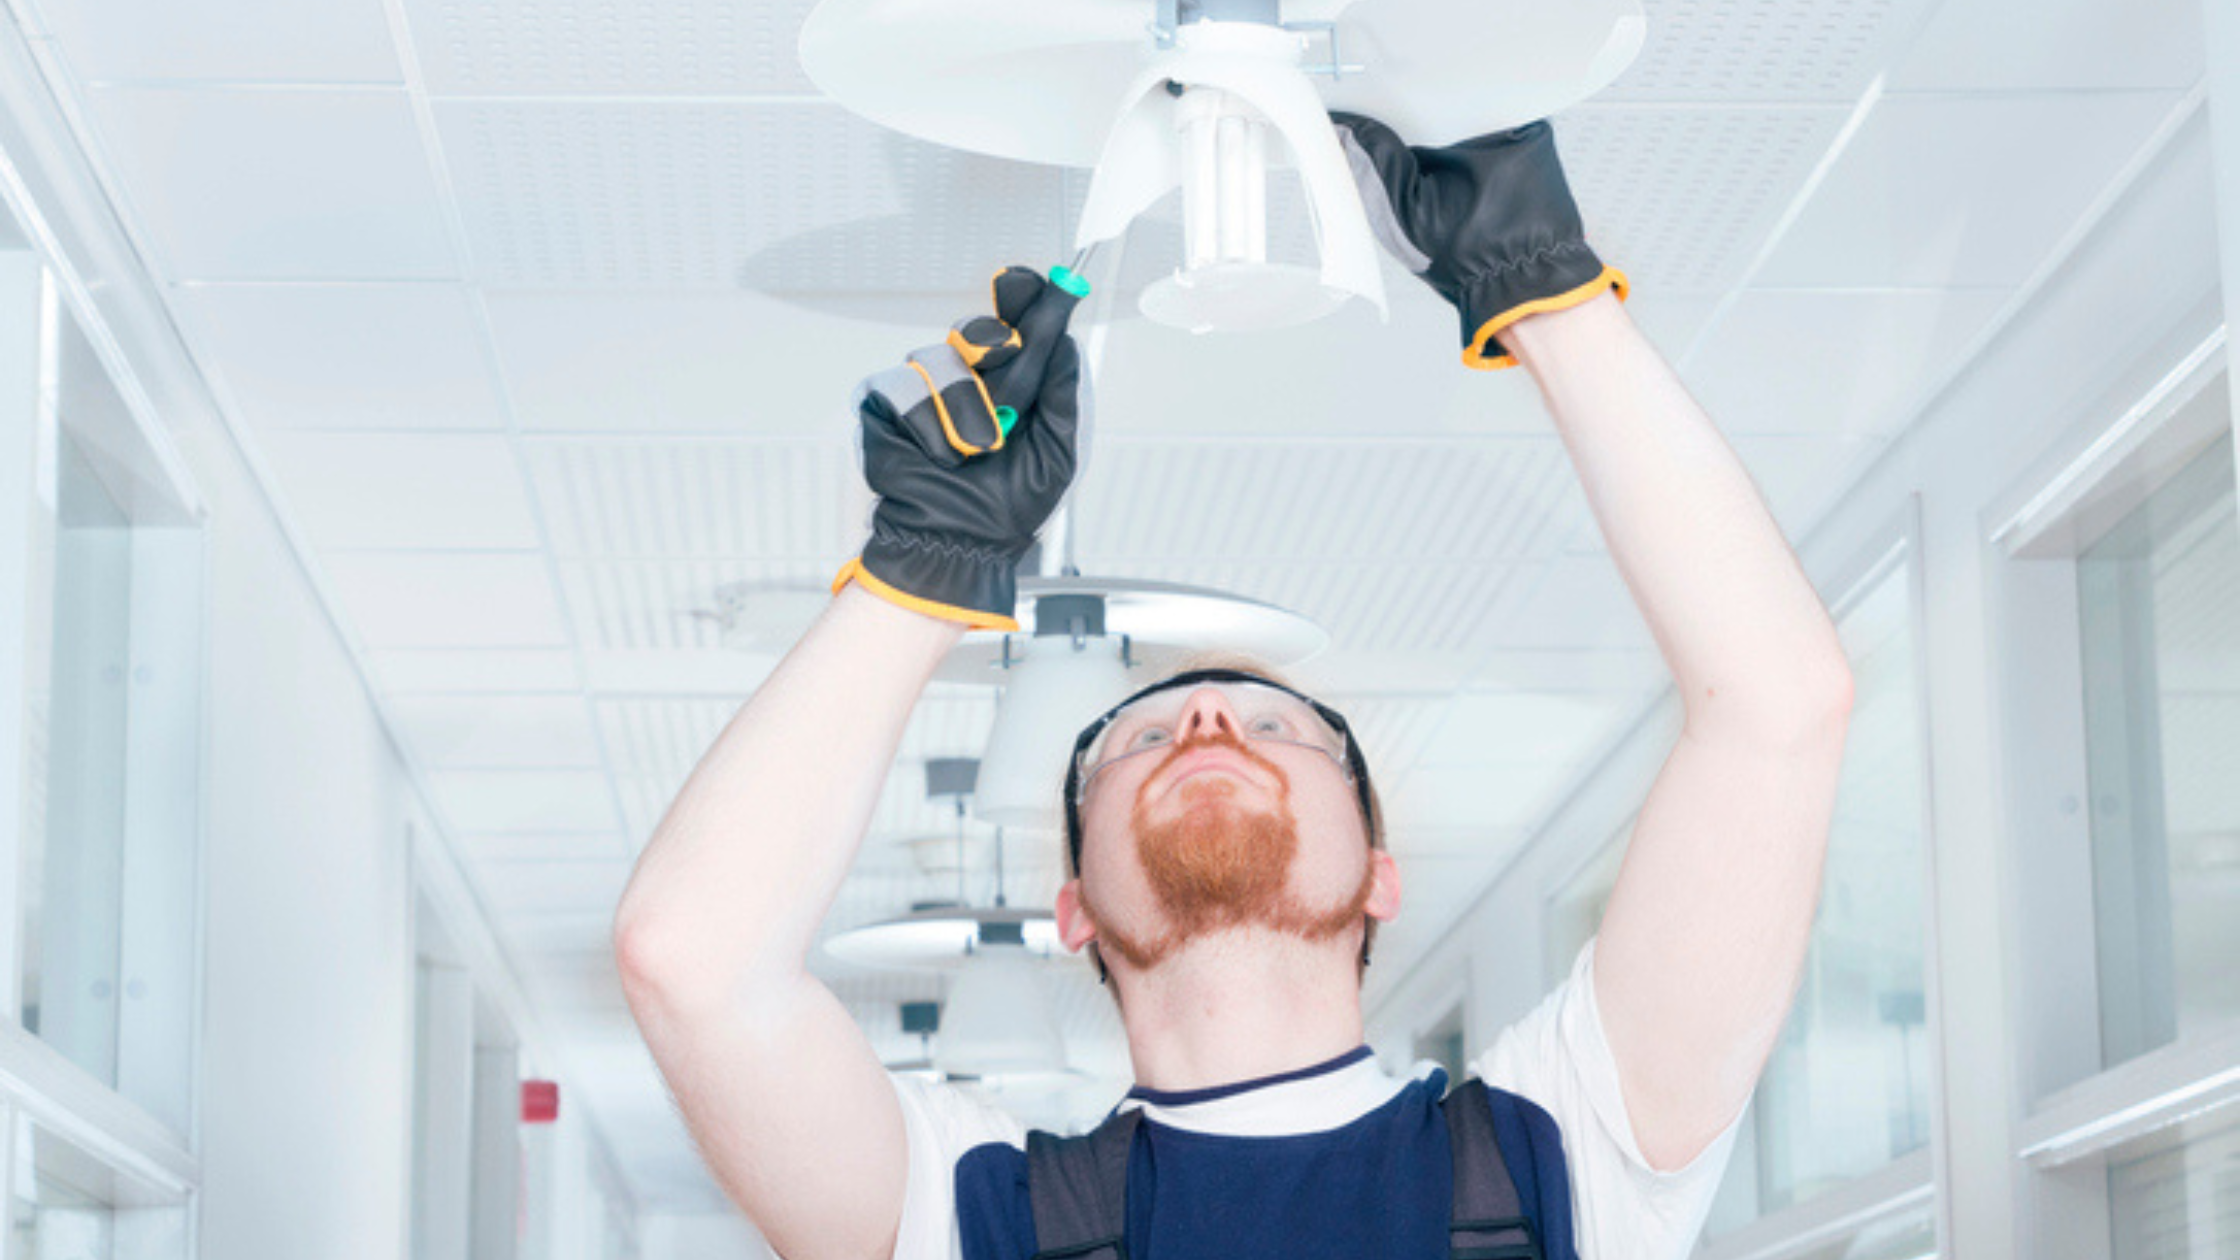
[{"x1": 1756, "y1": 92, "x2": 2177, "y2": 287}]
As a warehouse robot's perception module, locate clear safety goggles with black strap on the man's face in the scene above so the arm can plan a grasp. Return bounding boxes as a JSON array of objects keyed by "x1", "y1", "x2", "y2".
[{"x1": 1068, "y1": 670, "x2": 1357, "y2": 805}]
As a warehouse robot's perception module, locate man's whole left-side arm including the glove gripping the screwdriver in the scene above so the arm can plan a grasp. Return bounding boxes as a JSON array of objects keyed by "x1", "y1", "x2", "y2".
[{"x1": 614, "y1": 269, "x2": 1080, "y2": 1260}]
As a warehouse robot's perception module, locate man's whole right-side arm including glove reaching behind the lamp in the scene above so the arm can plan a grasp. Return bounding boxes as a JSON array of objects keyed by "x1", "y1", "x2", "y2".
[{"x1": 1333, "y1": 114, "x2": 1850, "y2": 1168}]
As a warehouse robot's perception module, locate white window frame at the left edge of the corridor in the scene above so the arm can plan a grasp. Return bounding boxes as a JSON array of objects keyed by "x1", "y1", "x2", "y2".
[{"x1": 0, "y1": 46, "x2": 211, "y2": 1256}]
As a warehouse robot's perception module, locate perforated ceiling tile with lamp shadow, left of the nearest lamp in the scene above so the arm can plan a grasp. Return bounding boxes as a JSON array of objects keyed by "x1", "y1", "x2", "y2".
[{"x1": 437, "y1": 99, "x2": 1064, "y2": 294}]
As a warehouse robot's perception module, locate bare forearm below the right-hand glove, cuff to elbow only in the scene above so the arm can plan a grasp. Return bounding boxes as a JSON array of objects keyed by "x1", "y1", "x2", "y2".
[{"x1": 1501, "y1": 296, "x2": 1846, "y2": 724}]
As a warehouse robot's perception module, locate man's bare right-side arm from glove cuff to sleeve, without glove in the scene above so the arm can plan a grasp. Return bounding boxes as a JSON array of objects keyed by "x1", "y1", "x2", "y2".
[{"x1": 1501, "y1": 296, "x2": 1850, "y2": 1168}]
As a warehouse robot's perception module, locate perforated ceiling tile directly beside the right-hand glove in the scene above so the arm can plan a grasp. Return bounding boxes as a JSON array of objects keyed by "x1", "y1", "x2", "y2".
[{"x1": 1555, "y1": 103, "x2": 1850, "y2": 298}]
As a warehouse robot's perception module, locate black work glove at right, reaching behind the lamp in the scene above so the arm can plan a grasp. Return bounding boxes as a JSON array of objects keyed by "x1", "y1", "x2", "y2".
[{"x1": 1331, "y1": 112, "x2": 1628, "y2": 370}]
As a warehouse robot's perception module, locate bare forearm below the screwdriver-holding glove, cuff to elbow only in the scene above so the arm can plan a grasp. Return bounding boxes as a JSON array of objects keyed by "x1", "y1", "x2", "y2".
[{"x1": 616, "y1": 585, "x2": 963, "y2": 991}]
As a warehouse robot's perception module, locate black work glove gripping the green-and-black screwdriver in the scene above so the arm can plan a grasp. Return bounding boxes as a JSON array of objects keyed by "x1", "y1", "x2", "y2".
[{"x1": 833, "y1": 267, "x2": 1089, "y2": 630}]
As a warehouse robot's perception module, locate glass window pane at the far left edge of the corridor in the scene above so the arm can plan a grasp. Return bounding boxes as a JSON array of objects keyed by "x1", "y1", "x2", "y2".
[{"x1": 0, "y1": 285, "x2": 202, "y2": 1139}]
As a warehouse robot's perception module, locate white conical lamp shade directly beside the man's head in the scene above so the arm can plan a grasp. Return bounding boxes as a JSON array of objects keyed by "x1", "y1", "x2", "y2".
[{"x1": 972, "y1": 634, "x2": 1129, "y2": 832}]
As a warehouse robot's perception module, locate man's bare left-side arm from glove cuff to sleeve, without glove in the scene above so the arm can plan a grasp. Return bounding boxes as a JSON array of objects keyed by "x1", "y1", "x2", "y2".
[{"x1": 614, "y1": 585, "x2": 963, "y2": 1260}]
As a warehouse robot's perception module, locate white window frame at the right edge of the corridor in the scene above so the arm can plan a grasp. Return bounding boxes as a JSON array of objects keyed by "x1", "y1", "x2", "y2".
[{"x1": 1982, "y1": 323, "x2": 2240, "y2": 1256}]
